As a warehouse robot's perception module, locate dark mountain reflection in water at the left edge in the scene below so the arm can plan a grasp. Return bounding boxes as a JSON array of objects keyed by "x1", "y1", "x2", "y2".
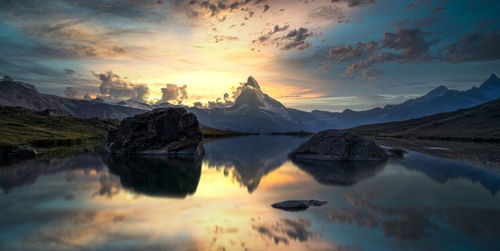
[{"x1": 0, "y1": 155, "x2": 103, "y2": 193}]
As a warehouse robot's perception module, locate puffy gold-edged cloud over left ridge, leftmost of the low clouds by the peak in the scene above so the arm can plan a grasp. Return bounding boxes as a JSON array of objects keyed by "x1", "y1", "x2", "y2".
[{"x1": 92, "y1": 71, "x2": 149, "y2": 102}]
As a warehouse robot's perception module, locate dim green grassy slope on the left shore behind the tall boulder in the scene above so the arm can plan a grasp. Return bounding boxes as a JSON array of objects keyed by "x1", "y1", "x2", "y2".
[{"x1": 0, "y1": 107, "x2": 119, "y2": 155}]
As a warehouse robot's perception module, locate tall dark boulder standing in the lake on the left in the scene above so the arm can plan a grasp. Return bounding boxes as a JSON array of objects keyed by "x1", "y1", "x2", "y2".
[{"x1": 103, "y1": 108, "x2": 204, "y2": 156}]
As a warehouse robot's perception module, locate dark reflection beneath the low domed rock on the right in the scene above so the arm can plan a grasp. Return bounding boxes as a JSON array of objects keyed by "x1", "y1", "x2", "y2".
[{"x1": 292, "y1": 160, "x2": 385, "y2": 186}]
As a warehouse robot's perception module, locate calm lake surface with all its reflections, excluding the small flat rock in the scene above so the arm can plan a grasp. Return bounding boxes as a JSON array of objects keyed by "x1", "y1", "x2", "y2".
[{"x1": 0, "y1": 136, "x2": 500, "y2": 250}]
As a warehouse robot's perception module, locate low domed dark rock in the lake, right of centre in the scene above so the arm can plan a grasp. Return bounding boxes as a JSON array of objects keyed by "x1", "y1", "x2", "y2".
[{"x1": 290, "y1": 130, "x2": 387, "y2": 161}]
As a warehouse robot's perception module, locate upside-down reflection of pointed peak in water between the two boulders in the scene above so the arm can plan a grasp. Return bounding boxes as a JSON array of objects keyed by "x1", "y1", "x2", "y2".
[{"x1": 203, "y1": 136, "x2": 307, "y2": 193}]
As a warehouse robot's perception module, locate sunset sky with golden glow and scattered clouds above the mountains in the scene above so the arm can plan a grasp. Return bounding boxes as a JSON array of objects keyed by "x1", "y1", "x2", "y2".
[{"x1": 0, "y1": 0, "x2": 500, "y2": 111}]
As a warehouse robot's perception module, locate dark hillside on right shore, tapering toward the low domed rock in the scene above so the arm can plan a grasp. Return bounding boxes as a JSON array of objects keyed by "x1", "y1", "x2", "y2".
[{"x1": 349, "y1": 99, "x2": 500, "y2": 142}]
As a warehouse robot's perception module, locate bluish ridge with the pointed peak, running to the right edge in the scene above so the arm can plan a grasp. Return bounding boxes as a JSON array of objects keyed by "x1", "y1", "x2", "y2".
[{"x1": 189, "y1": 74, "x2": 500, "y2": 132}]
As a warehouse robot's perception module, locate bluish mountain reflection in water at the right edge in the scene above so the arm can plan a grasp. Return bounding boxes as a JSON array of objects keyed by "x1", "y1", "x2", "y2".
[{"x1": 400, "y1": 152, "x2": 500, "y2": 195}]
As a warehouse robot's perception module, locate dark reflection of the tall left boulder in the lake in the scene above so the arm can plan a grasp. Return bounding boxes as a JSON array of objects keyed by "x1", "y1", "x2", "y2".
[{"x1": 102, "y1": 155, "x2": 201, "y2": 198}]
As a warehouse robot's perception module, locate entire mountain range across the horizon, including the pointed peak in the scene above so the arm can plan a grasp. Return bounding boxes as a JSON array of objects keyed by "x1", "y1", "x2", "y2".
[{"x1": 0, "y1": 74, "x2": 500, "y2": 132}]
